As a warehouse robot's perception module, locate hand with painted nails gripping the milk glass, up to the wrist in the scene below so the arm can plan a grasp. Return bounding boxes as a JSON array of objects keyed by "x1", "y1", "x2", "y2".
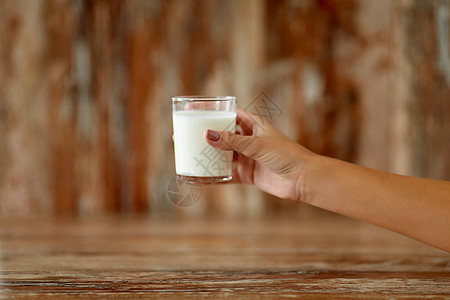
[{"x1": 205, "y1": 109, "x2": 315, "y2": 200}]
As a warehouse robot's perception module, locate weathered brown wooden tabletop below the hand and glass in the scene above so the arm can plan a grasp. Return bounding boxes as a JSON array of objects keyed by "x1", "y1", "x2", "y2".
[{"x1": 0, "y1": 210, "x2": 450, "y2": 299}]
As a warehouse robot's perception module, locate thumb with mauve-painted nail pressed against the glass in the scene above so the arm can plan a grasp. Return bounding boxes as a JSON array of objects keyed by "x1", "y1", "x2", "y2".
[{"x1": 205, "y1": 129, "x2": 261, "y2": 159}]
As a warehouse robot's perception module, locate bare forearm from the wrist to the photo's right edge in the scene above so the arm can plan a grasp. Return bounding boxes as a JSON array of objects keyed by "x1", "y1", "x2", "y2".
[{"x1": 302, "y1": 156, "x2": 450, "y2": 251}]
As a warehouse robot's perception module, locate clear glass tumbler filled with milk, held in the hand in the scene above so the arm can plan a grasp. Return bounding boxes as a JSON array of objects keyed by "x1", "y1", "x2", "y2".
[{"x1": 172, "y1": 96, "x2": 237, "y2": 183}]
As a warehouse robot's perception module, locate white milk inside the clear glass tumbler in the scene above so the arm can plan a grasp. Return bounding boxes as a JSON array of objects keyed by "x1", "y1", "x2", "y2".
[{"x1": 172, "y1": 110, "x2": 236, "y2": 177}]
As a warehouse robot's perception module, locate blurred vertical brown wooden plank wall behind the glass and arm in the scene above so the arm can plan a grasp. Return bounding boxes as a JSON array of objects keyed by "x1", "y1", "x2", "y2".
[{"x1": 0, "y1": 0, "x2": 450, "y2": 216}]
